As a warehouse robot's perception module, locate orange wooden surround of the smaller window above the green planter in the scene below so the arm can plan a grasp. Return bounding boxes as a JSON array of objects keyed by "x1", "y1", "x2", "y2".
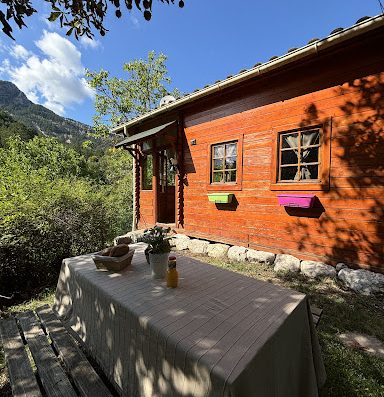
[{"x1": 206, "y1": 135, "x2": 243, "y2": 191}]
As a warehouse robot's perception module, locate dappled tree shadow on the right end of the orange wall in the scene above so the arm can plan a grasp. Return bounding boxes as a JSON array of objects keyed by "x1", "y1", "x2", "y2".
[{"x1": 287, "y1": 73, "x2": 384, "y2": 272}]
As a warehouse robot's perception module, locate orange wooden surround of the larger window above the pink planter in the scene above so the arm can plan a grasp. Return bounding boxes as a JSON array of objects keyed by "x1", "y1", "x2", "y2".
[{"x1": 270, "y1": 121, "x2": 331, "y2": 190}]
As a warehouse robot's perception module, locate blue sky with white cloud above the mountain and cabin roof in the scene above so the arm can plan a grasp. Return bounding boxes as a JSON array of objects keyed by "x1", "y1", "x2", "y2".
[{"x1": 0, "y1": 0, "x2": 380, "y2": 124}]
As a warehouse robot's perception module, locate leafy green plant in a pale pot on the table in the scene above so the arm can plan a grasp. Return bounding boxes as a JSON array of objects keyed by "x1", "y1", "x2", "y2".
[{"x1": 141, "y1": 226, "x2": 171, "y2": 278}]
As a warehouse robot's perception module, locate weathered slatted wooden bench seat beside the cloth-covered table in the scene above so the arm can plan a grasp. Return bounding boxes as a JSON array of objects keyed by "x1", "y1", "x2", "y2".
[{"x1": 0, "y1": 306, "x2": 116, "y2": 397}]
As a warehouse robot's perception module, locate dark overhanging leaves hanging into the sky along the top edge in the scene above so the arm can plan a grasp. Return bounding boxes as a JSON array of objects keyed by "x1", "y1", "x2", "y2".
[{"x1": 0, "y1": 0, "x2": 184, "y2": 38}]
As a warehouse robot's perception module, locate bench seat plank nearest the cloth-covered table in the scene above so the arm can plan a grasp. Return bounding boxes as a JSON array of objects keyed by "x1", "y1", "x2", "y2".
[{"x1": 36, "y1": 305, "x2": 112, "y2": 397}]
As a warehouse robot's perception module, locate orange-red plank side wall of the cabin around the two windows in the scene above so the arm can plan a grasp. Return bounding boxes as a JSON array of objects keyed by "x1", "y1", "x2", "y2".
[{"x1": 181, "y1": 31, "x2": 384, "y2": 272}]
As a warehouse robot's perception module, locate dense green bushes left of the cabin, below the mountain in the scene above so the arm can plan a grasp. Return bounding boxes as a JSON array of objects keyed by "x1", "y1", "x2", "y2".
[{"x1": 0, "y1": 137, "x2": 132, "y2": 294}]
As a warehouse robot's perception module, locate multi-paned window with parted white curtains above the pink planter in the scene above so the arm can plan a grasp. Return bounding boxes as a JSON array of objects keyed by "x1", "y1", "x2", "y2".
[{"x1": 277, "y1": 128, "x2": 321, "y2": 183}]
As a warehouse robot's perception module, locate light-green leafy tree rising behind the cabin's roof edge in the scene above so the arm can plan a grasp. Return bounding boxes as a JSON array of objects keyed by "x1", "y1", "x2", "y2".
[{"x1": 86, "y1": 51, "x2": 180, "y2": 136}]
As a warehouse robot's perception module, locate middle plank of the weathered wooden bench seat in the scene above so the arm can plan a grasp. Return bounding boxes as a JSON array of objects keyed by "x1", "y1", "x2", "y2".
[{"x1": 18, "y1": 311, "x2": 77, "y2": 397}]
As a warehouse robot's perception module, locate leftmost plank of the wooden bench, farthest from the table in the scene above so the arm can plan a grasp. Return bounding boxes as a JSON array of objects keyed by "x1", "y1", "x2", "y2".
[{"x1": 0, "y1": 318, "x2": 41, "y2": 397}]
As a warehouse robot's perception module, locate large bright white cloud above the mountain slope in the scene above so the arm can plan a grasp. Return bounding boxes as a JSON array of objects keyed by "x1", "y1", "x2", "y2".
[{"x1": 0, "y1": 31, "x2": 94, "y2": 115}]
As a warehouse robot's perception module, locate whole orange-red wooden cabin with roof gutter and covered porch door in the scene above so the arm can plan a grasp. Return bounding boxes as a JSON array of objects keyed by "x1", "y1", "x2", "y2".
[{"x1": 114, "y1": 16, "x2": 384, "y2": 272}]
